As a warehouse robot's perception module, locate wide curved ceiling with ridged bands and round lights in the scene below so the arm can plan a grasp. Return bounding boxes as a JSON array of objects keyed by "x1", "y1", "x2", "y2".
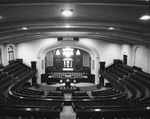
[{"x1": 0, "y1": 0, "x2": 150, "y2": 46}]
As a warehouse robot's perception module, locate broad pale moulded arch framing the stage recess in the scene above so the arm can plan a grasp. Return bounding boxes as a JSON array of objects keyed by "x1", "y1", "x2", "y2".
[{"x1": 37, "y1": 41, "x2": 100, "y2": 84}]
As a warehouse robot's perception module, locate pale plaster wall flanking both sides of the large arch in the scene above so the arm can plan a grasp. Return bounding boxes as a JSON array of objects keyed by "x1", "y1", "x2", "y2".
[{"x1": 16, "y1": 38, "x2": 123, "y2": 65}]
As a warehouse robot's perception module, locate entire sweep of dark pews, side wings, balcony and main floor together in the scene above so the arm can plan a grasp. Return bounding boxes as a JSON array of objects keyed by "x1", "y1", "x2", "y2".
[{"x1": 0, "y1": 61, "x2": 150, "y2": 119}]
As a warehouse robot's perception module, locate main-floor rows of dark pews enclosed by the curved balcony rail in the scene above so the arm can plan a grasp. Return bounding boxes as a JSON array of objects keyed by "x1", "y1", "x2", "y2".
[{"x1": 12, "y1": 87, "x2": 124, "y2": 102}]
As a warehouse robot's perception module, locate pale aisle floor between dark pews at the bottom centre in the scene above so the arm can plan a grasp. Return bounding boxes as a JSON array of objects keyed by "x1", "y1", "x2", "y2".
[{"x1": 60, "y1": 105, "x2": 76, "y2": 119}]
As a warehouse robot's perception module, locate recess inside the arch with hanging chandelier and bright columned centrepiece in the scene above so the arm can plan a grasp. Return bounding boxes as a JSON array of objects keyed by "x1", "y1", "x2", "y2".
[{"x1": 45, "y1": 46, "x2": 91, "y2": 70}]
